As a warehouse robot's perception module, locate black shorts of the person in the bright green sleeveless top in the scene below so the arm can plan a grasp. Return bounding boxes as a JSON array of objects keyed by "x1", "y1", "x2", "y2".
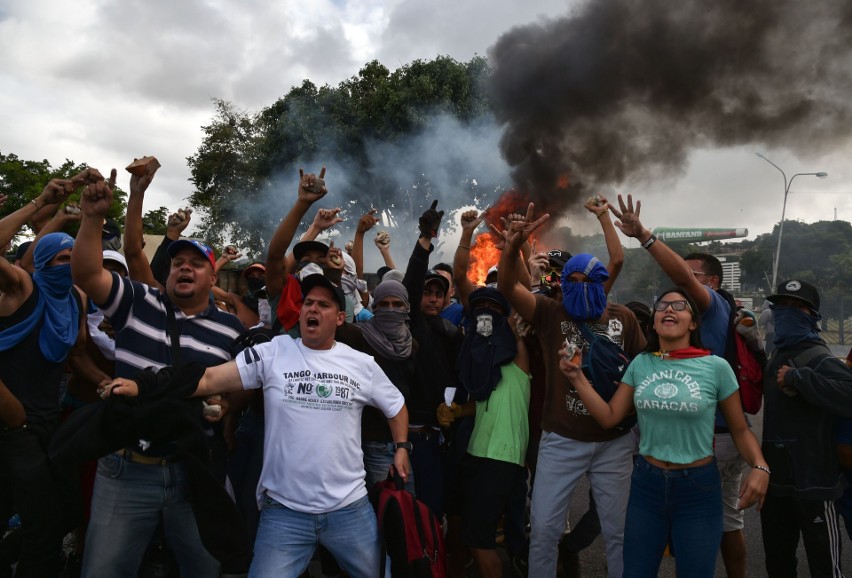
[{"x1": 462, "y1": 454, "x2": 524, "y2": 550}]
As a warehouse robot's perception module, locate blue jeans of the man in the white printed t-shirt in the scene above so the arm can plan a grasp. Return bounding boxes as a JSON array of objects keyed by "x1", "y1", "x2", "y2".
[{"x1": 249, "y1": 496, "x2": 381, "y2": 578}]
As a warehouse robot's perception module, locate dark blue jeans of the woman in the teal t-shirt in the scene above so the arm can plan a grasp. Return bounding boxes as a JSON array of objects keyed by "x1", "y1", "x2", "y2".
[{"x1": 624, "y1": 456, "x2": 722, "y2": 578}]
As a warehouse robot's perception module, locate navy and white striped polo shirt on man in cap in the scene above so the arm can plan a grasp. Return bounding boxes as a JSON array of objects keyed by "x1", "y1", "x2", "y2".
[{"x1": 101, "y1": 273, "x2": 243, "y2": 378}]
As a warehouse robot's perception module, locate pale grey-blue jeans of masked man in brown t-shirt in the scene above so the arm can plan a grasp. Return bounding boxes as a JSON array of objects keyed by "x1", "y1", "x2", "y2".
[{"x1": 529, "y1": 432, "x2": 633, "y2": 578}]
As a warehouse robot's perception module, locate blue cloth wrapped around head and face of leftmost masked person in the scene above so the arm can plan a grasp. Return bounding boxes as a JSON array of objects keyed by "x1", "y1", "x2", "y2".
[{"x1": 0, "y1": 233, "x2": 80, "y2": 362}]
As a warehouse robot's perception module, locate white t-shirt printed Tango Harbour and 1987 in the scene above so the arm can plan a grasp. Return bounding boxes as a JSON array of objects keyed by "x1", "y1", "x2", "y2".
[{"x1": 236, "y1": 335, "x2": 405, "y2": 514}]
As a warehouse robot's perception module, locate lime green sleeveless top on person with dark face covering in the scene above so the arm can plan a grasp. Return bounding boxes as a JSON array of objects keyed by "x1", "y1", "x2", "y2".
[{"x1": 467, "y1": 363, "x2": 530, "y2": 466}]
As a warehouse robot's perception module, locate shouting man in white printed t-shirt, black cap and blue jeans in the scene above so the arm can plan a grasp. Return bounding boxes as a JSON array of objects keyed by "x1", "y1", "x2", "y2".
[{"x1": 107, "y1": 274, "x2": 411, "y2": 578}]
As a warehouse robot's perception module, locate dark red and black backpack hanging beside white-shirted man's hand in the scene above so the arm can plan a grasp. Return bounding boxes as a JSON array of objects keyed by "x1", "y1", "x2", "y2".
[{"x1": 376, "y1": 470, "x2": 447, "y2": 578}]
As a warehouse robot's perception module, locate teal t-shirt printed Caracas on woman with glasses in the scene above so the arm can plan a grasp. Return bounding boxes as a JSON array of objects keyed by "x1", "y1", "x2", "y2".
[{"x1": 622, "y1": 353, "x2": 739, "y2": 464}]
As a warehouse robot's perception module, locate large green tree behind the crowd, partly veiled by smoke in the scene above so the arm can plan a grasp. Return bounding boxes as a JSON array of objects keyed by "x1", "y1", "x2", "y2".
[{"x1": 187, "y1": 56, "x2": 497, "y2": 252}]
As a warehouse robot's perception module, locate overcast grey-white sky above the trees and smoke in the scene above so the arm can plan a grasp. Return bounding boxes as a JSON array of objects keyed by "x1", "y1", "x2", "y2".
[{"x1": 0, "y1": 0, "x2": 852, "y2": 252}]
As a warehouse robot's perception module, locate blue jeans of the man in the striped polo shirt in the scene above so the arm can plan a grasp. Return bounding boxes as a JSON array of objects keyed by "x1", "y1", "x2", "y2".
[{"x1": 83, "y1": 454, "x2": 219, "y2": 578}]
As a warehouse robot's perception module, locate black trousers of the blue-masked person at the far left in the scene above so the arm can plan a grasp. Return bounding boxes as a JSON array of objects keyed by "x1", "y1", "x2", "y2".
[{"x1": 0, "y1": 424, "x2": 82, "y2": 578}]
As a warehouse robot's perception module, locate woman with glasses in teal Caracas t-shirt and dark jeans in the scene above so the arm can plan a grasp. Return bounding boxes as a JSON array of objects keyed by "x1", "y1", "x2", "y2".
[{"x1": 559, "y1": 288, "x2": 769, "y2": 578}]
